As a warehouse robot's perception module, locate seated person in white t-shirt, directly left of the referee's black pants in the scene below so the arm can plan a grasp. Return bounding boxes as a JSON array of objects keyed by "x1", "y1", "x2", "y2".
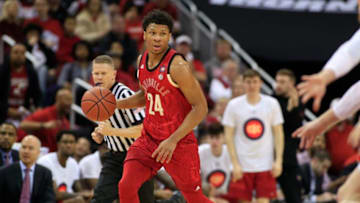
[{"x1": 79, "y1": 142, "x2": 108, "y2": 190}]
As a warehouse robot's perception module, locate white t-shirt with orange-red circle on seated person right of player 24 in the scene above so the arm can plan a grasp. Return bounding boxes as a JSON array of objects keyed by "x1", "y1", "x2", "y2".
[{"x1": 199, "y1": 144, "x2": 232, "y2": 194}]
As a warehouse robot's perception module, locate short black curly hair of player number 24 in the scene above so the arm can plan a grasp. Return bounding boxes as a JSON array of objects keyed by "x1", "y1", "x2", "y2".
[{"x1": 143, "y1": 9, "x2": 174, "y2": 33}]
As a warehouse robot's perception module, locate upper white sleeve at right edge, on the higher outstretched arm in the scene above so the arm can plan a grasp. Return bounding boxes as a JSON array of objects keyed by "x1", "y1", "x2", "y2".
[{"x1": 324, "y1": 29, "x2": 360, "y2": 78}]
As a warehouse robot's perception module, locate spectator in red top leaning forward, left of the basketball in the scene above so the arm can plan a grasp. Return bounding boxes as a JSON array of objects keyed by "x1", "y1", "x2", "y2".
[{"x1": 20, "y1": 89, "x2": 72, "y2": 152}]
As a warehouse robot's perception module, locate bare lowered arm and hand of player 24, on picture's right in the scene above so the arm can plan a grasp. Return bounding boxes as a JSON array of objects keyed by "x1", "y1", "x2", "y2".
[{"x1": 152, "y1": 56, "x2": 208, "y2": 163}]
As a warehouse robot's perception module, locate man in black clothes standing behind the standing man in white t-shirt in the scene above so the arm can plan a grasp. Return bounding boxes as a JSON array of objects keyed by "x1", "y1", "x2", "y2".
[{"x1": 274, "y1": 69, "x2": 304, "y2": 203}]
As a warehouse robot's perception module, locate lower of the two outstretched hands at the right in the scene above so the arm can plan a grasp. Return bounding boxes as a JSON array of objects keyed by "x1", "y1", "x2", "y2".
[{"x1": 292, "y1": 120, "x2": 327, "y2": 149}]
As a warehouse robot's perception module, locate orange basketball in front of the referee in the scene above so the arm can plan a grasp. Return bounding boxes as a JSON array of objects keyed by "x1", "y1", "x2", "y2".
[{"x1": 81, "y1": 87, "x2": 116, "y2": 121}]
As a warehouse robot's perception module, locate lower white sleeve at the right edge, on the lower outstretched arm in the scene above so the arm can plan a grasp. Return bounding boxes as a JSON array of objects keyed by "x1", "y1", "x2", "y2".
[{"x1": 332, "y1": 80, "x2": 360, "y2": 120}]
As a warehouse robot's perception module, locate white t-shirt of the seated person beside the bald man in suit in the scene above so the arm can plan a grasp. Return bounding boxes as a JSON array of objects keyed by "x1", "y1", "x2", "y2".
[{"x1": 38, "y1": 152, "x2": 80, "y2": 193}]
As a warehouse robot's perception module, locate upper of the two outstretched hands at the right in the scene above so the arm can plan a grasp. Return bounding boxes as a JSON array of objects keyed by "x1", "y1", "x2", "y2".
[{"x1": 297, "y1": 73, "x2": 326, "y2": 111}]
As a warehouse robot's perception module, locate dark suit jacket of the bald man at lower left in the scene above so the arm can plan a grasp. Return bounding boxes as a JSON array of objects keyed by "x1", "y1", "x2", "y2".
[{"x1": 0, "y1": 162, "x2": 56, "y2": 203}]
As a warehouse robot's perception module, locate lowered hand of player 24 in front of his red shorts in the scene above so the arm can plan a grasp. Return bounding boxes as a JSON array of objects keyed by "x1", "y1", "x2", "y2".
[{"x1": 151, "y1": 137, "x2": 177, "y2": 163}]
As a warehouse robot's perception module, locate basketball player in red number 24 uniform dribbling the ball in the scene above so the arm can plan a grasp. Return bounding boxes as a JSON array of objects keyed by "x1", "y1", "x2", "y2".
[{"x1": 117, "y1": 10, "x2": 211, "y2": 203}]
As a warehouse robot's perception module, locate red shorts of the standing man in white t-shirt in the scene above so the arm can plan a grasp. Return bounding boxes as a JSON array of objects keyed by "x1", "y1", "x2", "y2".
[{"x1": 228, "y1": 171, "x2": 276, "y2": 201}]
